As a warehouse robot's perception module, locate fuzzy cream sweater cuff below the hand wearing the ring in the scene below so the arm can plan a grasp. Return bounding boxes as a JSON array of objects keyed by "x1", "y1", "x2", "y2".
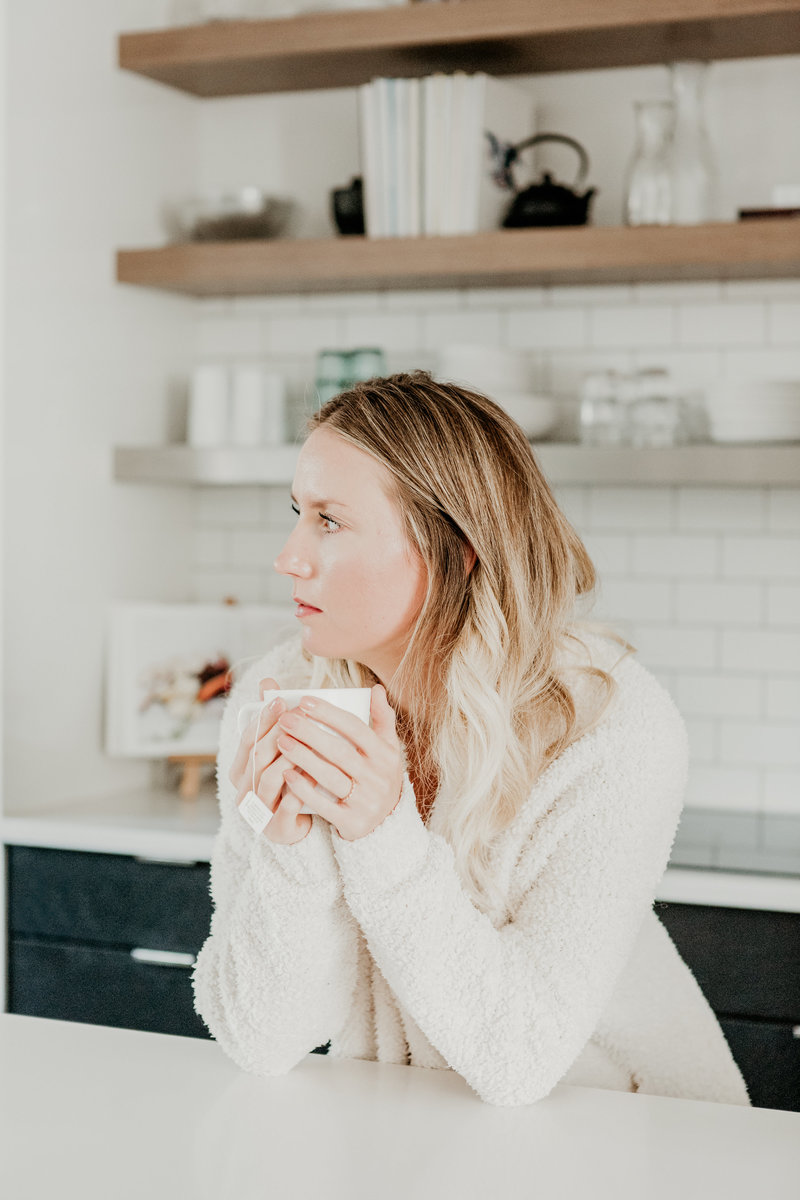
[{"x1": 331, "y1": 775, "x2": 429, "y2": 892}]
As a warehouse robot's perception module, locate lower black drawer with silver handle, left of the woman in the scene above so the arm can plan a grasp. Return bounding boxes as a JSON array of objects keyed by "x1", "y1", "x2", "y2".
[{"x1": 8, "y1": 938, "x2": 210, "y2": 1038}]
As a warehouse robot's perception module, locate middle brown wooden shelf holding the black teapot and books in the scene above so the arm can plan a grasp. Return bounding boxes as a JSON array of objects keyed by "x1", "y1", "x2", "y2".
[{"x1": 116, "y1": 219, "x2": 800, "y2": 296}]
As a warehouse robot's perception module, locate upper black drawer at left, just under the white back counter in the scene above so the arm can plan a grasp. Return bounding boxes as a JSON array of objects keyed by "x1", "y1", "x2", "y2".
[{"x1": 8, "y1": 846, "x2": 211, "y2": 953}]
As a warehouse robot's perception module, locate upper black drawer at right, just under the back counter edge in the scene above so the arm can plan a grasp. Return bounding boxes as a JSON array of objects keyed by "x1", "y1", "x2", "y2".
[{"x1": 655, "y1": 902, "x2": 800, "y2": 1025}]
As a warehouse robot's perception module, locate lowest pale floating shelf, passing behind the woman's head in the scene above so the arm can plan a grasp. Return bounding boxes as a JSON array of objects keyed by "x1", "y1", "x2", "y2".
[{"x1": 114, "y1": 442, "x2": 800, "y2": 487}]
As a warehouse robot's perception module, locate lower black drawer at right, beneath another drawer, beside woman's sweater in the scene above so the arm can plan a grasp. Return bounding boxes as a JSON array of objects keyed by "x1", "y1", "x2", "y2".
[{"x1": 720, "y1": 1016, "x2": 800, "y2": 1112}]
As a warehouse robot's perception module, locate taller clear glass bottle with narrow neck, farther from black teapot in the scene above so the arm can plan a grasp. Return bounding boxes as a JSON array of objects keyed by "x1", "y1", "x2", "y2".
[{"x1": 670, "y1": 62, "x2": 716, "y2": 224}]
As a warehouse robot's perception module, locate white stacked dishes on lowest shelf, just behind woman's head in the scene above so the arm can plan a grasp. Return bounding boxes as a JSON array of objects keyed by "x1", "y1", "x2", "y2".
[{"x1": 437, "y1": 343, "x2": 559, "y2": 439}]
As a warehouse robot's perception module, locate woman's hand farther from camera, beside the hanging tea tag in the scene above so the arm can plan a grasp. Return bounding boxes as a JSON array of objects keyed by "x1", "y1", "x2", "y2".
[{"x1": 228, "y1": 679, "x2": 312, "y2": 846}]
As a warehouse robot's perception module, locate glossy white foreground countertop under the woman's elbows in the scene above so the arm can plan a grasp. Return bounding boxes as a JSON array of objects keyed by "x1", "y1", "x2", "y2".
[{"x1": 0, "y1": 1013, "x2": 800, "y2": 1200}]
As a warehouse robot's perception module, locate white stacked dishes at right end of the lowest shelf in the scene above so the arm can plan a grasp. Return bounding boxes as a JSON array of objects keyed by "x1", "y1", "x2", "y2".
[{"x1": 708, "y1": 379, "x2": 800, "y2": 442}]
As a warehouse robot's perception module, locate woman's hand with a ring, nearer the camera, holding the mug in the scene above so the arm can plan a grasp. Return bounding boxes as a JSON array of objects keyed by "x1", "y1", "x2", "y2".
[{"x1": 275, "y1": 684, "x2": 404, "y2": 841}]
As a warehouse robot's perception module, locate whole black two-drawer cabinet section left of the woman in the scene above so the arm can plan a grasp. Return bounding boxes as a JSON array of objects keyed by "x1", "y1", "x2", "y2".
[{"x1": 6, "y1": 846, "x2": 327, "y2": 1054}]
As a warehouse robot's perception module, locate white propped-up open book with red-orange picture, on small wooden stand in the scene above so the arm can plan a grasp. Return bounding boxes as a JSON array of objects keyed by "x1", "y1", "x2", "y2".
[{"x1": 104, "y1": 602, "x2": 297, "y2": 758}]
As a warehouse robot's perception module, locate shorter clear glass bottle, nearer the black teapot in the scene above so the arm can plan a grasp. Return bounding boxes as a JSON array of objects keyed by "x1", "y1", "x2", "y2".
[{"x1": 625, "y1": 100, "x2": 675, "y2": 226}]
